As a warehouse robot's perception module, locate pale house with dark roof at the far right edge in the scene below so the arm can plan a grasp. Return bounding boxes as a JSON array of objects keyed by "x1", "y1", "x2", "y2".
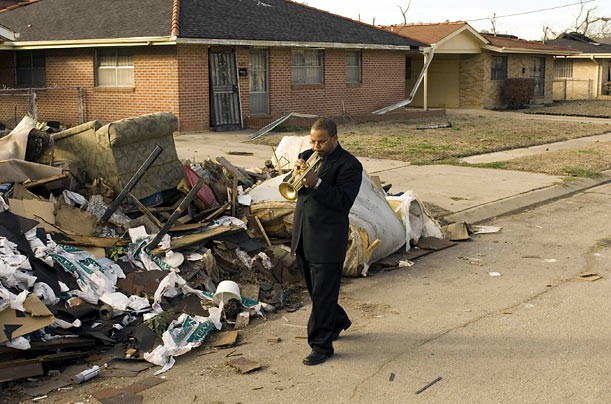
[{"x1": 547, "y1": 32, "x2": 611, "y2": 100}]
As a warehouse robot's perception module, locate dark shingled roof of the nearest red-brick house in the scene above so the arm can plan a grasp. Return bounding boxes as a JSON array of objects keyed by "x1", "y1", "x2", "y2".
[{"x1": 0, "y1": 0, "x2": 423, "y2": 49}]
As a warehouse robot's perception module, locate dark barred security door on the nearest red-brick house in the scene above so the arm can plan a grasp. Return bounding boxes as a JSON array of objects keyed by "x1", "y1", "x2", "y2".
[{"x1": 208, "y1": 49, "x2": 242, "y2": 131}]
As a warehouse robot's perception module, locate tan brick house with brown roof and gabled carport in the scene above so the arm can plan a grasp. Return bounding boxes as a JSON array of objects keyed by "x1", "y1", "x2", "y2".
[{"x1": 385, "y1": 21, "x2": 575, "y2": 109}]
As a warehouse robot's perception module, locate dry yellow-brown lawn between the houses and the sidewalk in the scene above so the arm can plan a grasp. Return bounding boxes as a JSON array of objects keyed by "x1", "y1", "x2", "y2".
[{"x1": 256, "y1": 111, "x2": 611, "y2": 172}]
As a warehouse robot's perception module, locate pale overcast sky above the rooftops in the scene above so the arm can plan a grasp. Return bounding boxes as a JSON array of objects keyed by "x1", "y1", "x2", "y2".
[{"x1": 300, "y1": 0, "x2": 611, "y2": 40}]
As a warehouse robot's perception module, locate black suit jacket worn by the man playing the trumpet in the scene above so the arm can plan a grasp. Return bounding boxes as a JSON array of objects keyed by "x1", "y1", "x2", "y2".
[{"x1": 291, "y1": 143, "x2": 363, "y2": 263}]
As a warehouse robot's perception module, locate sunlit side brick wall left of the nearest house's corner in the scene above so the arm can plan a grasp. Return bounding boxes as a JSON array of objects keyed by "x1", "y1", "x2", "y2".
[{"x1": 0, "y1": 46, "x2": 179, "y2": 126}]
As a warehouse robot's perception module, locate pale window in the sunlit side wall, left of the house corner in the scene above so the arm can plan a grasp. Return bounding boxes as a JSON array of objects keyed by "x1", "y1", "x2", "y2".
[{"x1": 96, "y1": 48, "x2": 134, "y2": 87}]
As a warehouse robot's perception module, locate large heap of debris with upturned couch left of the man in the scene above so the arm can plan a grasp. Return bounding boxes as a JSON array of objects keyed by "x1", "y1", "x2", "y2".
[{"x1": 0, "y1": 113, "x2": 302, "y2": 394}]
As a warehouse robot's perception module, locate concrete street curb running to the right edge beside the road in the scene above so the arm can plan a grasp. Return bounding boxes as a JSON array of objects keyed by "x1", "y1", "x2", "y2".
[{"x1": 442, "y1": 174, "x2": 611, "y2": 223}]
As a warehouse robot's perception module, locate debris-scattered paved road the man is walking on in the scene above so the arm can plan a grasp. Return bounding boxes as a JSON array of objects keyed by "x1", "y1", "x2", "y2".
[{"x1": 131, "y1": 185, "x2": 611, "y2": 404}]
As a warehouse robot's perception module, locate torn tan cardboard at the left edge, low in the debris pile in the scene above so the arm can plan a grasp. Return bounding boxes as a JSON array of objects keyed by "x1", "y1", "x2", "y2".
[{"x1": 0, "y1": 295, "x2": 55, "y2": 343}]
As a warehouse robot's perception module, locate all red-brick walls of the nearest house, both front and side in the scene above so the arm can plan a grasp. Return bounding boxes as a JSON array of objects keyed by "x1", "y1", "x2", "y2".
[{"x1": 0, "y1": 45, "x2": 406, "y2": 132}]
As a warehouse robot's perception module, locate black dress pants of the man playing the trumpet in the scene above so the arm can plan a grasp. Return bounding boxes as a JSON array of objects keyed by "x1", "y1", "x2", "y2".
[{"x1": 297, "y1": 246, "x2": 348, "y2": 355}]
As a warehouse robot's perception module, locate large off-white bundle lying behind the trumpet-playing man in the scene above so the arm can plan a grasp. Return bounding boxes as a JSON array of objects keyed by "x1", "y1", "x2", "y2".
[{"x1": 249, "y1": 136, "x2": 443, "y2": 277}]
